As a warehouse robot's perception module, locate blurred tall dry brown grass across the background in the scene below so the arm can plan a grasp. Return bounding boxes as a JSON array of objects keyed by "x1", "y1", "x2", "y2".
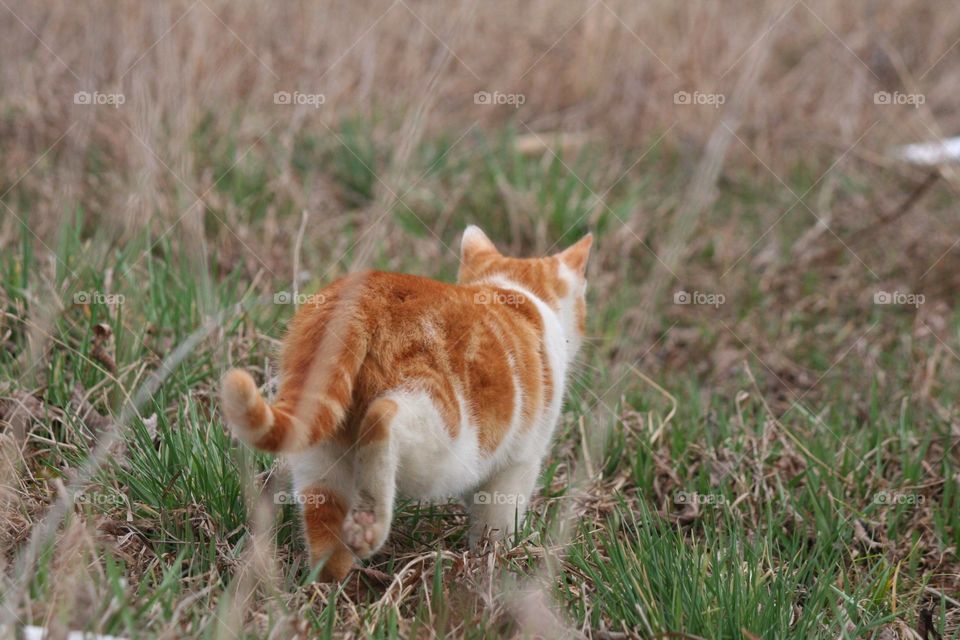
[{"x1": 0, "y1": 0, "x2": 960, "y2": 235}]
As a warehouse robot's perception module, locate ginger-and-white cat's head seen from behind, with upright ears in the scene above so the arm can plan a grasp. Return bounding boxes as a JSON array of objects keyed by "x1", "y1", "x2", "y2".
[{"x1": 457, "y1": 225, "x2": 593, "y2": 351}]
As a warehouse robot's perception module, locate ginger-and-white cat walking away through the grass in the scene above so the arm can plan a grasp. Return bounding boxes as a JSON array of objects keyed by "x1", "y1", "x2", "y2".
[{"x1": 221, "y1": 226, "x2": 592, "y2": 581}]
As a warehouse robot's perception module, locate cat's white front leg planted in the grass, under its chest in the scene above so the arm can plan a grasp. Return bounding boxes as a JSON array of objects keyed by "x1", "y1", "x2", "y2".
[{"x1": 466, "y1": 461, "x2": 540, "y2": 547}]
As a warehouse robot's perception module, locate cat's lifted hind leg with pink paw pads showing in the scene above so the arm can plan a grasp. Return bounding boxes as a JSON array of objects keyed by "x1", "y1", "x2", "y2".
[{"x1": 343, "y1": 398, "x2": 399, "y2": 558}]
